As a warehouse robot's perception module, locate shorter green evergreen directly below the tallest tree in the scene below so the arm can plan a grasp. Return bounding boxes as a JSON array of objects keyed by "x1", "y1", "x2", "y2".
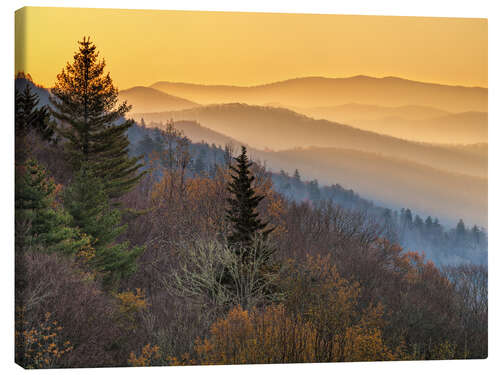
[{"x1": 64, "y1": 164, "x2": 143, "y2": 287}]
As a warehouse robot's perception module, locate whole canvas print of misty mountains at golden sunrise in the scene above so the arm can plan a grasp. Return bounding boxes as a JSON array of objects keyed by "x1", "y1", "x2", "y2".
[{"x1": 15, "y1": 7, "x2": 488, "y2": 369}]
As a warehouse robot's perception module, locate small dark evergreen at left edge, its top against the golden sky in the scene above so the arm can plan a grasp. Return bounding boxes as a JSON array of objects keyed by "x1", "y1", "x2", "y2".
[{"x1": 15, "y1": 82, "x2": 54, "y2": 164}]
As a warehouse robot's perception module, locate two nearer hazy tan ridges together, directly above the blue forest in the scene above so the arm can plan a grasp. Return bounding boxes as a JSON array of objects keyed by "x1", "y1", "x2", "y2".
[{"x1": 16, "y1": 75, "x2": 487, "y2": 227}]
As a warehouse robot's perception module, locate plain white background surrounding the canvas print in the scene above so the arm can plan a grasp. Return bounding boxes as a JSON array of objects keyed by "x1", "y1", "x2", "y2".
[{"x1": 0, "y1": 0, "x2": 500, "y2": 375}]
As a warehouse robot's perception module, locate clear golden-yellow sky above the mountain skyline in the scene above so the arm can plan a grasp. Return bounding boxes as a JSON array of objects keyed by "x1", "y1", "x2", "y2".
[{"x1": 16, "y1": 7, "x2": 488, "y2": 89}]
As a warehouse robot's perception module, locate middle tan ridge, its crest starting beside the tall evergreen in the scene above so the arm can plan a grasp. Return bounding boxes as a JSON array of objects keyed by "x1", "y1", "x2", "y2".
[{"x1": 132, "y1": 103, "x2": 488, "y2": 177}]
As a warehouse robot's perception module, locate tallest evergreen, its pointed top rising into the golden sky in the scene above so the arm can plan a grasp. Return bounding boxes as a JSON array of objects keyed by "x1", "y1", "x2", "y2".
[{"x1": 51, "y1": 38, "x2": 145, "y2": 198}]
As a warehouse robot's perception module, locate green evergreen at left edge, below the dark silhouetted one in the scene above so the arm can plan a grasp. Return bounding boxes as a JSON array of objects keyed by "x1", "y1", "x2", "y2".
[{"x1": 15, "y1": 159, "x2": 90, "y2": 254}]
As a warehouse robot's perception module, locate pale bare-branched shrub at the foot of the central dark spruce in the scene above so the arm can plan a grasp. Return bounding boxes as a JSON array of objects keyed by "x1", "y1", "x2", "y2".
[{"x1": 168, "y1": 238, "x2": 280, "y2": 310}]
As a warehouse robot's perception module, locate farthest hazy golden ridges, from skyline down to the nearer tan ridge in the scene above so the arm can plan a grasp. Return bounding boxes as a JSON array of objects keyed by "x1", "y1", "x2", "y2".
[{"x1": 145, "y1": 76, "x2": 488, "y2": 143}]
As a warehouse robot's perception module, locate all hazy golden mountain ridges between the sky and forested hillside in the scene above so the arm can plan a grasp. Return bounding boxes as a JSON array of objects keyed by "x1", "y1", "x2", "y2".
[{"x1": 16, "y1": 77, "x2": 488, "y2": 227}]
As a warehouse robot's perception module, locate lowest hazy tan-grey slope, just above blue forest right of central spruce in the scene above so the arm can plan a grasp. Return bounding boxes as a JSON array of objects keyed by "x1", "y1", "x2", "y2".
[{"x1": 260, "y1": 148, "x2": 488, "y2": 227}]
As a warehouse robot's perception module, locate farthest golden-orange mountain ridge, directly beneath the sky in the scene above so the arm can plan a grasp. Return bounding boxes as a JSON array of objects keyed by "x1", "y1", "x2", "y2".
[{"x1": 151, "y1": 76, "x2": 488, "y2": 112}]
